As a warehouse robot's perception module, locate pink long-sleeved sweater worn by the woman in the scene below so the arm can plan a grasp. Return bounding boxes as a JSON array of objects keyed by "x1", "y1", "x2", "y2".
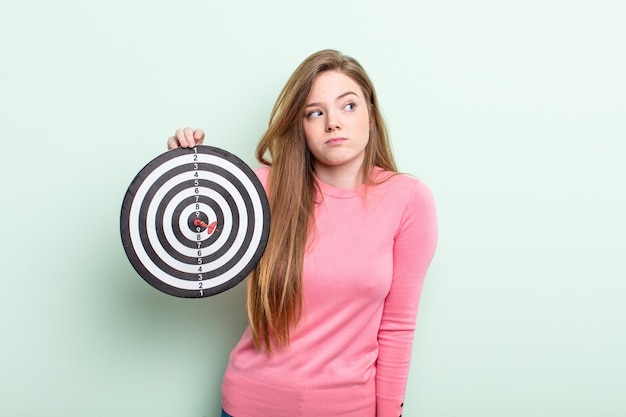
[{"x1": 222, "y1": 168, "x2": 437, "y2": 417}]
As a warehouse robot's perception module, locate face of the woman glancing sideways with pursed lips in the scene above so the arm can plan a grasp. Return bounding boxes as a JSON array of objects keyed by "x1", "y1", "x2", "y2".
[{"x1": 302, "y1": 71, "x2": 370, "y2": 181}]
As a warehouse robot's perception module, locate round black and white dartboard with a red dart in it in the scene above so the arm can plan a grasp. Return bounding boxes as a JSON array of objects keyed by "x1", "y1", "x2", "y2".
[{"x1": 120, "y1": 146, "x2": 270, "y2": 298}]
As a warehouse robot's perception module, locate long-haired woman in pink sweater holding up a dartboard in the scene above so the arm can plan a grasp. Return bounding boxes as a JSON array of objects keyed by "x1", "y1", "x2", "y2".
[{"x1": 168, "y1": 50, "x2": 437, "y2": 417}]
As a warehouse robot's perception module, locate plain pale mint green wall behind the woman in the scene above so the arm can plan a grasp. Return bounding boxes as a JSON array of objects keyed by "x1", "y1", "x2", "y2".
[{"x1": 0, "y1": 0, "x2": 626, "y2": 417}]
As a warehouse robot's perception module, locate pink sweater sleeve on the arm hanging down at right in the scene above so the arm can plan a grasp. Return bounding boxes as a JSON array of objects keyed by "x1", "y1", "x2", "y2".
[{"x1": 376, "y1": 182, "x2": 437, "y2": 417}]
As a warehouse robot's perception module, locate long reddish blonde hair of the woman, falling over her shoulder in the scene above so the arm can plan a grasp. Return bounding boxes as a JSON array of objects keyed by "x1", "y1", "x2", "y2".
[{"x1": 248, "y1": 50, "x2": 397, "y2": 353}]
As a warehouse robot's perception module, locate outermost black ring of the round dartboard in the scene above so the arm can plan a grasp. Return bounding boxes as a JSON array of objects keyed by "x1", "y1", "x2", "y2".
[{"x1": 120, "y1": 145, "x2": 270, "y2": 298}]
